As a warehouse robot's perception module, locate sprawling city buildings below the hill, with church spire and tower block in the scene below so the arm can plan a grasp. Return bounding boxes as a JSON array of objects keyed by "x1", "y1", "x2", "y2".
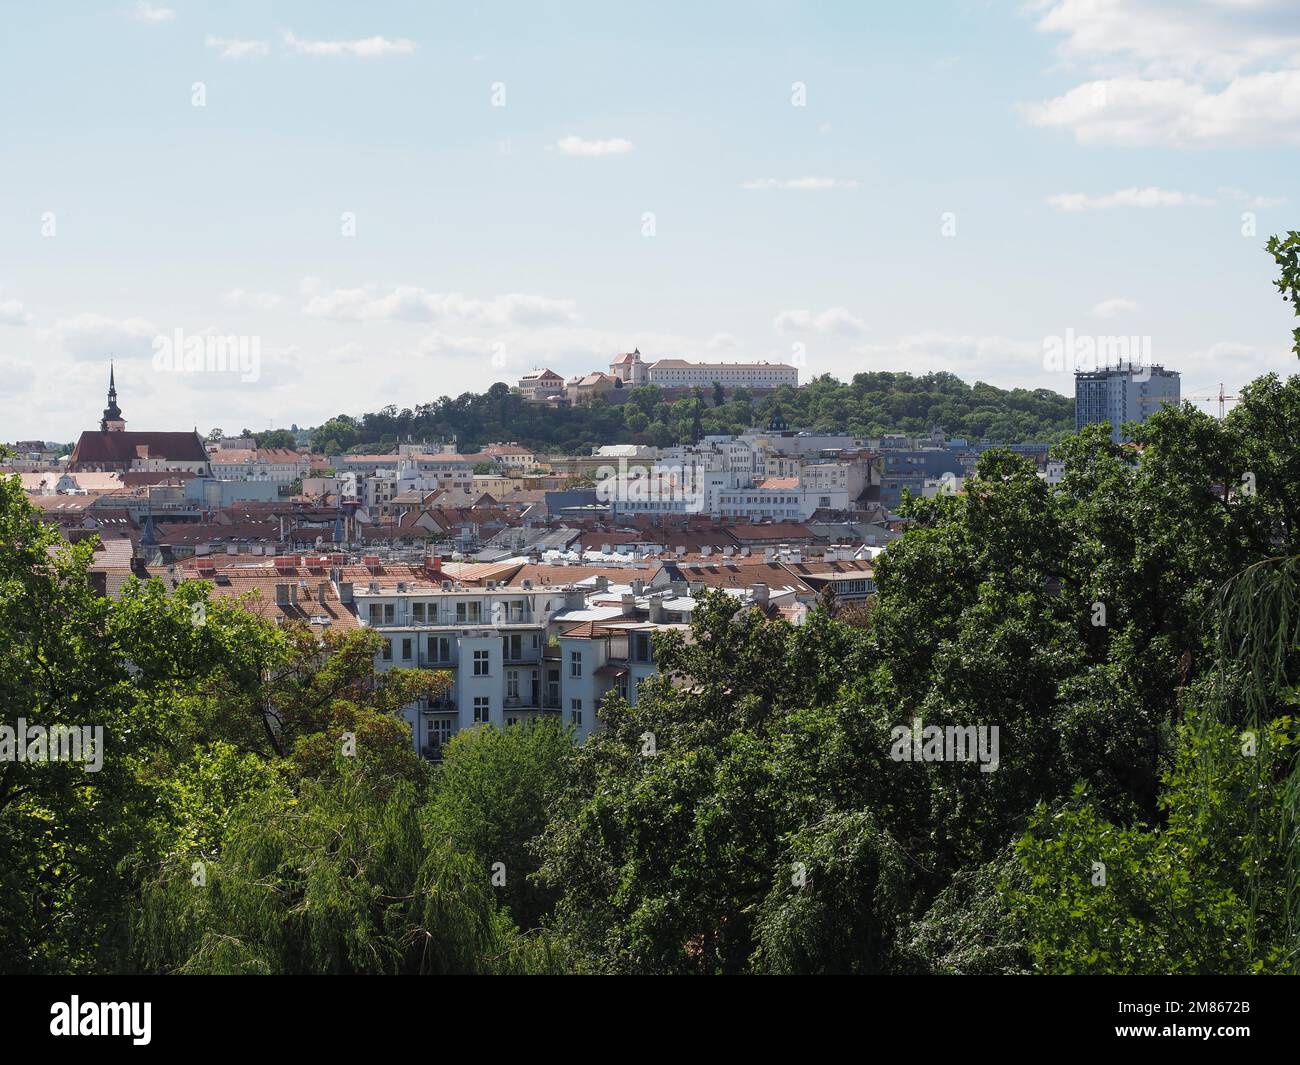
[{"x1": 5, "y1": 352, "x2": 1178, "y2": 758}]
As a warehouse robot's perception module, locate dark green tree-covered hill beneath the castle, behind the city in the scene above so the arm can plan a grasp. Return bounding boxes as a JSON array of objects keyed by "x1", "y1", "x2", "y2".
[{"x1": 312, "y1": 373, "x2": 1074, "y2": 454}]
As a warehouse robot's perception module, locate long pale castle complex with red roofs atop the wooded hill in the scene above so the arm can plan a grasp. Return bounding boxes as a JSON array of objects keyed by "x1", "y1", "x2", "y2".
[{"x1": 519, "y1": 348, "x2": 800, "y2": 406}]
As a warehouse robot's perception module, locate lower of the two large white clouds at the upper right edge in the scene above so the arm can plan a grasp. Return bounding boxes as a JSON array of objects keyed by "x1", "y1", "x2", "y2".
[{"x1": 1021, "y1": 70, "x2": 1300, "y2": 148}]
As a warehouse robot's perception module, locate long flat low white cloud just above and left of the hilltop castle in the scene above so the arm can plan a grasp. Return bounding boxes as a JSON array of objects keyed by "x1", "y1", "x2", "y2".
[{"x1": 302, "y1": 278, "x2": 577, "y2": 325}]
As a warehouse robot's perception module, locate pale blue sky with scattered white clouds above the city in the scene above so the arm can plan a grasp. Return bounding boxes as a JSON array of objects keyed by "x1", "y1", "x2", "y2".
[{"x1": 0, "y1": 0, "x2": 1300, "y2": 440}]
